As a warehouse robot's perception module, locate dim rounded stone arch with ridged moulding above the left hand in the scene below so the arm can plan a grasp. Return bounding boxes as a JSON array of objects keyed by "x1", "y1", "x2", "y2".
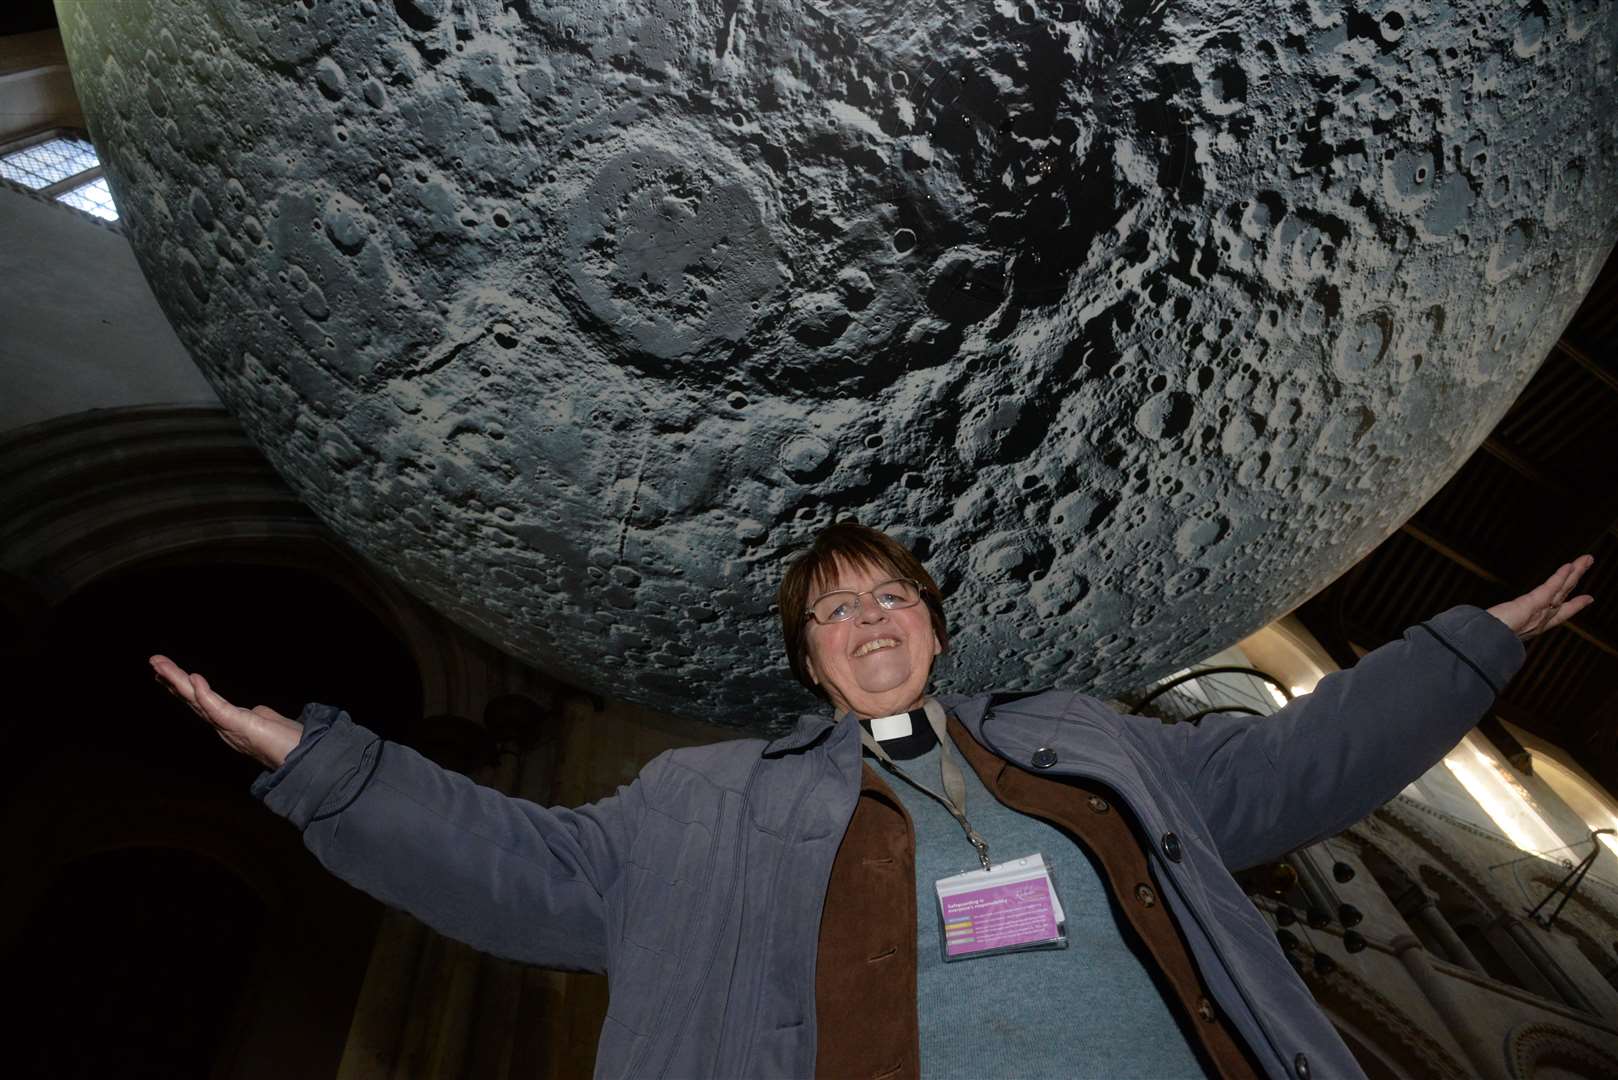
[{"x1": 0, "y1": 405, "x2": 560, "y2": 716}]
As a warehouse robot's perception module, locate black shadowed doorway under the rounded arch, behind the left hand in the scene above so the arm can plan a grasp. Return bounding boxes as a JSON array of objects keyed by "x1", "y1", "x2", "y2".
[{"x1": 0, "y1": 557, "x2": 421, "y2": 1080}]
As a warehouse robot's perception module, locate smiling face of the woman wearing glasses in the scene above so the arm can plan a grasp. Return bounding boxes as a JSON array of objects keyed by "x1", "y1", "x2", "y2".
[{"x1": 809, "y1": 565, "x2": 942, "y2": 717}]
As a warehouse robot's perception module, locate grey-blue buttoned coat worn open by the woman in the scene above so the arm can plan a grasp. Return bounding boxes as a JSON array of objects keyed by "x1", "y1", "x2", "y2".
[{"x1": 254, "y1": 607, "x2": 1523, "y2": 1080}]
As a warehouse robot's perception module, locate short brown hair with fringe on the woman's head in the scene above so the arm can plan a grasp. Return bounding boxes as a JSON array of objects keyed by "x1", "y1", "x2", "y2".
[{"x1": 778, "y1": 521, "x2": 950, "y2": 698}]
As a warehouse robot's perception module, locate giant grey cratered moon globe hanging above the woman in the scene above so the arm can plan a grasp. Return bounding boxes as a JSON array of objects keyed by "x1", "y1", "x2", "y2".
[{"x1": 61, "y1": 0, "x2": 1618, "y2": 730}]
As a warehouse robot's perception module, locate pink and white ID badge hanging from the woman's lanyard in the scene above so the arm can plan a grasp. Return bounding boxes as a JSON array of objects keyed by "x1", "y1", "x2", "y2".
[{"x1": 934, "y1": 852, "x2": 1068, "y2": 963}]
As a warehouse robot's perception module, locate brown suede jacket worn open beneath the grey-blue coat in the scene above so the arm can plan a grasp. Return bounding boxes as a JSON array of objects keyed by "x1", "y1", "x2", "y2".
[{"x1": 815, "y1": 717, "x2": 1264, "y2": 1080}]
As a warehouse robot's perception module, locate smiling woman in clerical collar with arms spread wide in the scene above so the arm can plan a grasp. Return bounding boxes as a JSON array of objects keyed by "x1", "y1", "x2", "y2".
[{"x1": 152, "y1": 523, "x2": 1592, "y2": 1080}]
